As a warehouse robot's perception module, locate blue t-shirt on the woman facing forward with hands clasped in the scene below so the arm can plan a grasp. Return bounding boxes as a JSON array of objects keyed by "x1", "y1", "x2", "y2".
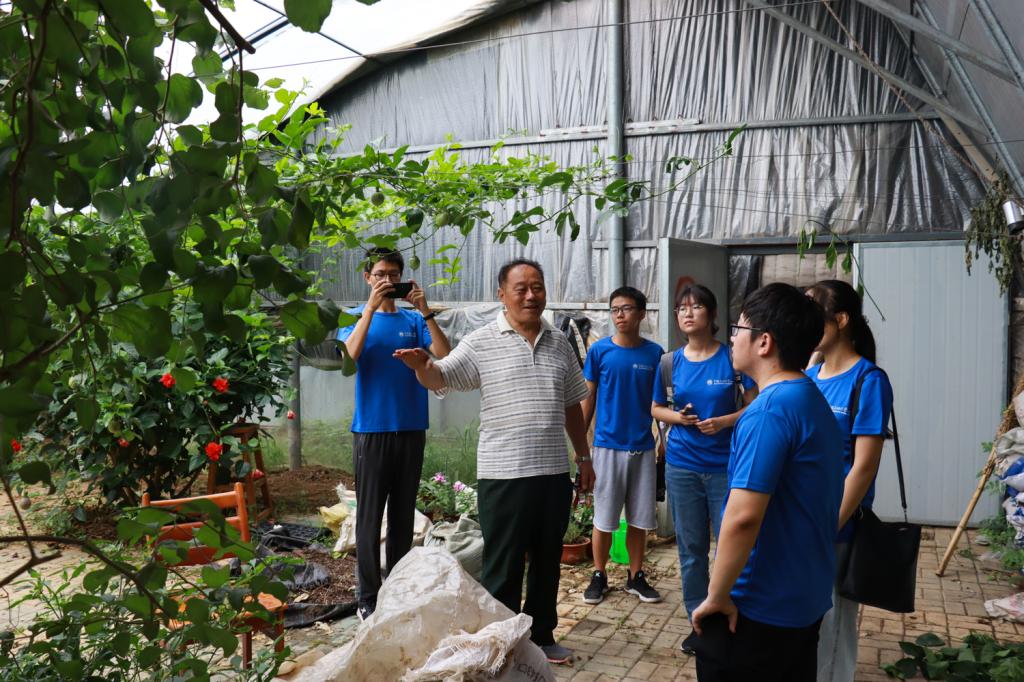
[{"x1": 653, "y1": 344, "x2": 754, "y2": 473}]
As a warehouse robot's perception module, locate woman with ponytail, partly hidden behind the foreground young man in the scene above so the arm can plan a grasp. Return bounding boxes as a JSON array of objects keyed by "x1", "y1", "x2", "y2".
[{"x1": 807, "y1": 280, "x2": 893, "y2": 682}]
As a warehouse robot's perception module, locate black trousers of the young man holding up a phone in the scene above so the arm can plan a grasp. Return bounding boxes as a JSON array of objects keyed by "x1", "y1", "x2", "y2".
[{"x1": 352, "y1": 431, "x2": 427, "y2": 605}]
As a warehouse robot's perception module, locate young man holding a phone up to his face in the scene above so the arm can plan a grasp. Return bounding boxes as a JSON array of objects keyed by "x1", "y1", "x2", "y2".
[{"x1": 338, "y1": 248, "x2": 451, "y2": 620}]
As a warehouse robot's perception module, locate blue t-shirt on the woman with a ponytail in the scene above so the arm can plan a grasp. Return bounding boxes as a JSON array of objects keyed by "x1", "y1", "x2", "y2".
[{"x1": 807, "y1": 357, "x2": 893, "y2": 542}]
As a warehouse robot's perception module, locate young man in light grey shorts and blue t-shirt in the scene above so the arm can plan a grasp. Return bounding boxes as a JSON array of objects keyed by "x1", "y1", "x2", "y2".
[{"x1": 583, "y1": 287, "x2": 665, "y2": 604}]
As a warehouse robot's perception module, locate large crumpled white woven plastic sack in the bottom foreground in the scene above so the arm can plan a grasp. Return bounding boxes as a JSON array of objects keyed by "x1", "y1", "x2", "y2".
[{"x1": 296, "y1": 547, "x2": 554, "y2": 682}]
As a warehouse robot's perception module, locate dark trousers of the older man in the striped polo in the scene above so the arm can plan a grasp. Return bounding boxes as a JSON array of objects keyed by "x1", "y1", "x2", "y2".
[{"x1": 477, "y1": 473, "x2": 572, "y2": 646}]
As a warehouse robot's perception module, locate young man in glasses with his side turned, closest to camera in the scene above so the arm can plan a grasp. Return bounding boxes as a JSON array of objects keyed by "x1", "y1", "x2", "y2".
[{"x1": 687, "y1": 284, "x2": 843, "y2": 682}]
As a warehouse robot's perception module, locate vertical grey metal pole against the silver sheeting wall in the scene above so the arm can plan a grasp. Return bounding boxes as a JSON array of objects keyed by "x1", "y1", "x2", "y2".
[{"x1": 607, "y1": 0, "x2": 626, "y2": 293}]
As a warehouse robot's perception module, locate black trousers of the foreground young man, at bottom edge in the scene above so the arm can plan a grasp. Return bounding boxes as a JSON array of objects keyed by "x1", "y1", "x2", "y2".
[{"x1": 694, "y1": 615, "x2": 821, "y2": 682}]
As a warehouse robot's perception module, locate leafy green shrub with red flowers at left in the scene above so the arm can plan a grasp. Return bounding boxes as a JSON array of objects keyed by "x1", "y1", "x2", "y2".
[{"x1": 35, "y1": 302, "x2": 292, "y2": 505}]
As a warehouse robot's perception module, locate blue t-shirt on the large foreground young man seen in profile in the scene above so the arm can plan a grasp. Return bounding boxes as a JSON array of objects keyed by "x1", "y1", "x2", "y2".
[{"x1": 726, "y1": 379, "x2": 843, "y2": 628}]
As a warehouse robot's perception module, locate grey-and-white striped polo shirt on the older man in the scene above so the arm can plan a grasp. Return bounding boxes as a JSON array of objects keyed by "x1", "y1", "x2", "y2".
[{"x1": 434, "y1": 311, "x2": 589, "y2": 478}]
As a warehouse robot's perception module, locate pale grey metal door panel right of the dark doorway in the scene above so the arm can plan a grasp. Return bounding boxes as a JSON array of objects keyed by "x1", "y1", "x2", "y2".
[{"x1": 854, "y1": 242, "x2": 1009, "y2": 525}]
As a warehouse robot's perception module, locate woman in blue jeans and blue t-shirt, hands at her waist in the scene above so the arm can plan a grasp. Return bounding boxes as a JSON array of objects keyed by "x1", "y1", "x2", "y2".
[{"x1": 651, "y1": 284, "x2": 757, "y2": 638}]
